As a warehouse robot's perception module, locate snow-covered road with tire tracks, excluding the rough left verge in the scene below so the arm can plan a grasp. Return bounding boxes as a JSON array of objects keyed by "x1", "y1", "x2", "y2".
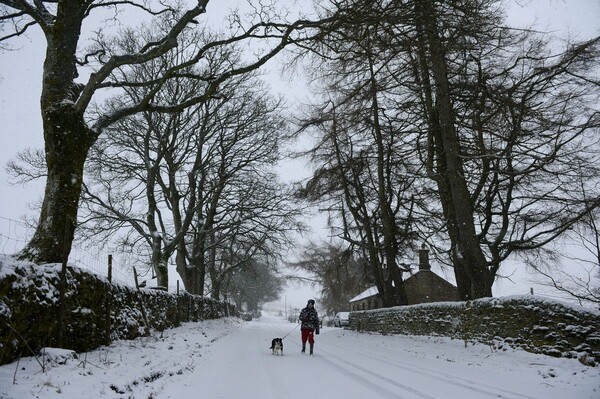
[{"x1": 165, "y1": 317, "x2": 600, "y2": 399}]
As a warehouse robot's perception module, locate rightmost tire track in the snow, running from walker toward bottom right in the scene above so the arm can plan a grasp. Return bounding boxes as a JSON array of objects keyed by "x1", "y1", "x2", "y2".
[{"x1": 324, "y1": 342, "x2": 539, "y2": 399}]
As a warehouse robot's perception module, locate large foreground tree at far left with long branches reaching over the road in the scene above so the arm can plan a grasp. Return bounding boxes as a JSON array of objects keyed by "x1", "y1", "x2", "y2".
[{"x1": 0, "y1": 0, "x2": 328, "y2": 262}]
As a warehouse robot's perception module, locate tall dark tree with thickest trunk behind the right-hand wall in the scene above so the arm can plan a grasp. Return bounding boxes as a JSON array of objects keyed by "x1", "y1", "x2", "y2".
[{"x1": 298, "y1": 0, "x2": 600, "y2": 299}]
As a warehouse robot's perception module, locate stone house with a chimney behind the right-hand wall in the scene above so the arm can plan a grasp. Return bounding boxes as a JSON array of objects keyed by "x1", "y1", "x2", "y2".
[{"x1": 349, "y1": 246, "x2": 459, "y2": 311}]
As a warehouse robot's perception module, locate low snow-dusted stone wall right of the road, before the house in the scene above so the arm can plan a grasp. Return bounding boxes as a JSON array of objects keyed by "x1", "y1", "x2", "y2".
[{"x1": 350, "y1": 296, "x2": 600, "y2": 365}]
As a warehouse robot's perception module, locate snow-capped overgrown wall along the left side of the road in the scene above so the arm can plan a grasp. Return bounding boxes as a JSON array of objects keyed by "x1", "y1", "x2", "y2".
[{"x1": 0, "y1": 264, "x2": 237, "y2": 364}]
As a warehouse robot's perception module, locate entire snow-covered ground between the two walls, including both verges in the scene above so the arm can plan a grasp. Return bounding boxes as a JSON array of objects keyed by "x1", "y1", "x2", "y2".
[{"x1": 0, "y1": 315, "x2": 600, "y2": 399}]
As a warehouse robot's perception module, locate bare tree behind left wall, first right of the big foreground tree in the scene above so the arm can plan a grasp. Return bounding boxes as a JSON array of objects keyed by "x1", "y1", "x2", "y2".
[{"x1": 81, "y1": 23, "x2": 236, "y2": 287}]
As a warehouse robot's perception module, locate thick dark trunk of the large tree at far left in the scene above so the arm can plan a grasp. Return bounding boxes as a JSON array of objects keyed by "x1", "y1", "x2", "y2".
[{"x1": 19, "y1": 7, "x2": 91, "y2": 263}]
